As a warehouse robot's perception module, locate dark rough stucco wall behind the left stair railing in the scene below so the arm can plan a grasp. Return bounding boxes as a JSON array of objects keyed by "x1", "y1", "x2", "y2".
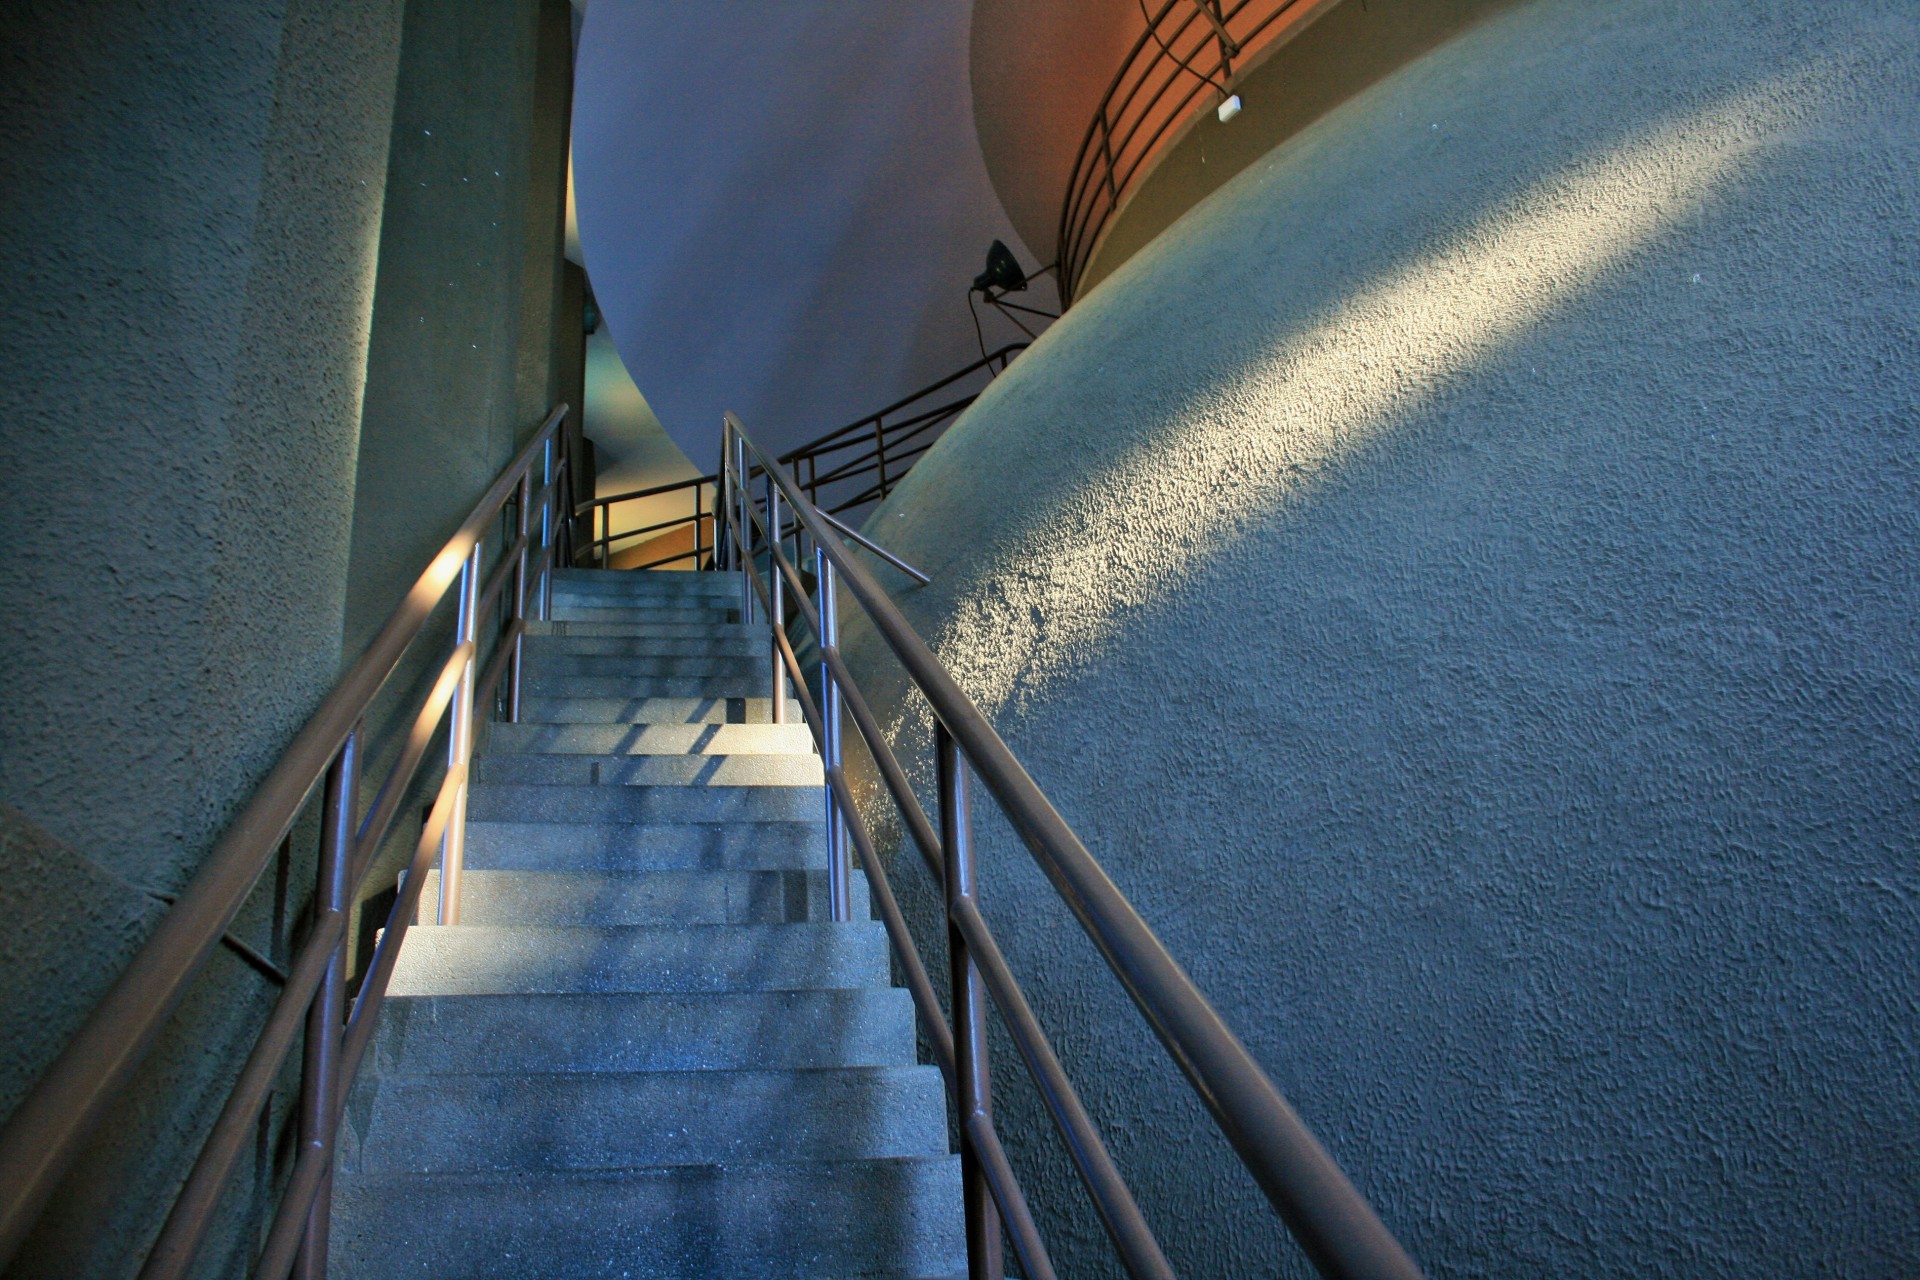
[{"x1": 0, "y1": 0, "x2": 399, "y2": 1280}]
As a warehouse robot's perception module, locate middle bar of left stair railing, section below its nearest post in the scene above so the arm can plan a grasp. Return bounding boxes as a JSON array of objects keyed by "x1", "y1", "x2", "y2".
[{"x1": 140, "y1": 912, "x2": 348, "y2": 1280}]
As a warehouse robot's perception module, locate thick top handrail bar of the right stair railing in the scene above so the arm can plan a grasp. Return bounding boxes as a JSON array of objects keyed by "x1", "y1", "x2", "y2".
[{"x1": 728, "y1": 415, "x2": 1421, "y2": 1280}]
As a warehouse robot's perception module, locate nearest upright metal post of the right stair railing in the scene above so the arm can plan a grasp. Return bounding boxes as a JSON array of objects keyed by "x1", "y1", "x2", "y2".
[{"x1": 933, "y1": 720, "x2": 1006, "y2": 1280}]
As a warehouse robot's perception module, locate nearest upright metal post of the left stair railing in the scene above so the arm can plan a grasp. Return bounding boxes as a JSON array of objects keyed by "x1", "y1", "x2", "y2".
[{"x1": 294, "y1": 725, "x2": 361, "y2": 1280}]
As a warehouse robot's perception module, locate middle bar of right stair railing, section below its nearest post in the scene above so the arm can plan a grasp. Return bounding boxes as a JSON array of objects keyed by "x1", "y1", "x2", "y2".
[{"x1": 947, "y1": 898, "x2": 1173, "y2": 1280}]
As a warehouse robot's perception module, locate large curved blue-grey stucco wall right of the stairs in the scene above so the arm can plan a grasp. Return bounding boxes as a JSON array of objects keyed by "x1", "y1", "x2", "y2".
[{"x1": 849, "y1": 0, "x2": 1920, "y2": 1278}]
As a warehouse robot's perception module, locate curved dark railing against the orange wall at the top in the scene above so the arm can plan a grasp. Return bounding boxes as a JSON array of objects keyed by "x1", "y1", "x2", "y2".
[{"x1": 1056, "y1": 0, "x2": 1323, "y2": 307}]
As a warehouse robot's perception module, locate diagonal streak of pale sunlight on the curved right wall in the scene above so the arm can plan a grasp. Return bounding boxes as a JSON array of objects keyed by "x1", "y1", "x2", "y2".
[{"x1": 935, "y1": 71, "x2": 1837, "y2": 714}]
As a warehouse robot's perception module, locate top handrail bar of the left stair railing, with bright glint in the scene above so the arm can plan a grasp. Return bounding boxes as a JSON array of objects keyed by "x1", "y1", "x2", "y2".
[{"x1": 0, "y1": 405, "x2": 566, "y2": 1270}]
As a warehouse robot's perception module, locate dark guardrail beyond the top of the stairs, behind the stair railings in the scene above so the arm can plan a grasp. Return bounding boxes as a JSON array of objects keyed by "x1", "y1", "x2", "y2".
[{"x1": 576, "y1": 342, "x2": 1027, "y2": 570}]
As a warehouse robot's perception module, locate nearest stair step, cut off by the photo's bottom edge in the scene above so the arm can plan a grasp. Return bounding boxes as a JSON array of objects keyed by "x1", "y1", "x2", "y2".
[{"x1": 332, "y1": 1155, "x2": 966, "y2": 1280}]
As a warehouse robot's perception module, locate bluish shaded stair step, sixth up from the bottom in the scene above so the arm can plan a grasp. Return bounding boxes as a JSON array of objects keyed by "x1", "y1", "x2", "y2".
[{"x1": 467, "y1": 810, "x2": 828, "y2": 871}]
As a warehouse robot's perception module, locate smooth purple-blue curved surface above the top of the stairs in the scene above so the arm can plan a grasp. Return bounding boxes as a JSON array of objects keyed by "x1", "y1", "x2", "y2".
[{"x1": 574, "y1": 0, "x2": 1037, "y2": 466}]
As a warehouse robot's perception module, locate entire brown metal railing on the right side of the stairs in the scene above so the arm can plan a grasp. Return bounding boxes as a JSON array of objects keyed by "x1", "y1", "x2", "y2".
[{"x1": 718, "y1": 415, "x2": 1421, "y2": 1280}]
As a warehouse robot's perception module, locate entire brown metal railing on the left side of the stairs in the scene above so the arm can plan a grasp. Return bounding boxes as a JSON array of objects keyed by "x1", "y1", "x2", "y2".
[{"x1": 0, "y1": 405, "x2": 572, "y2": 1280}]
